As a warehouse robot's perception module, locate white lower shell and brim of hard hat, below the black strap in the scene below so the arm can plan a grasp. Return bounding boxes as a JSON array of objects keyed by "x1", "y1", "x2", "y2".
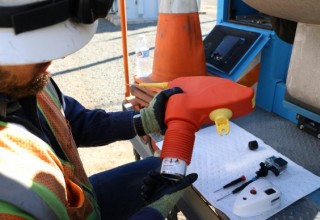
[{"x1": 0, "y1": 20, "x2": 98, "y2": 65}]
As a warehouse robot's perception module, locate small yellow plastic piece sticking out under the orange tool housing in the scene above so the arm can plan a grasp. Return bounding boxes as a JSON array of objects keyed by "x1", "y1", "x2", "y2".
[{"x1": 209, "y1": 108, "x2": 232, "y2": 135}]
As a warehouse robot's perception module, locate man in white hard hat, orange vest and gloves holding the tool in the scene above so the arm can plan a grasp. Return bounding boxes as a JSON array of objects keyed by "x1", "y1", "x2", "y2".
[{"x1": 0, "y1": 0, "x2": 197, "y2": 220}]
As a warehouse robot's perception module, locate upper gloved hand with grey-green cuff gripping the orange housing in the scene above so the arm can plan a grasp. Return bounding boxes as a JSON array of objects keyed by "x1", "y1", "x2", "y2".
[{"x1": 140, "y1": 87, "x2": 183, "y2": 134}]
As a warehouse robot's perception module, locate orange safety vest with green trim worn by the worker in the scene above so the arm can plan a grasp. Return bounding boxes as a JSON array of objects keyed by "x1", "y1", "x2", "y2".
[{"x1": 0, "y1": 83, "x2": 100, "y2": 219}]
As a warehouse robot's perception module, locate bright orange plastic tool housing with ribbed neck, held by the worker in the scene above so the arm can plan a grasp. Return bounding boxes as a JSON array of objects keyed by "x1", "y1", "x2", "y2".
[{"x1": 160, "y1": 76, "x2": 254, "y2": 164}]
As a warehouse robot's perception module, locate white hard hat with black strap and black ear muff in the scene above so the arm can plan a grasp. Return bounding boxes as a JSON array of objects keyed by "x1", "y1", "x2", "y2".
[{"x1": 0, "y1": 0, "x2": 113, "y2": 65}]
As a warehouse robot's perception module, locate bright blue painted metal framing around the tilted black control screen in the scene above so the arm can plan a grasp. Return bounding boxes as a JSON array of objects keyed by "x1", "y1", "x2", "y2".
[{"x1": 208, "y1": 0, "x2": 295, "y2": 122}]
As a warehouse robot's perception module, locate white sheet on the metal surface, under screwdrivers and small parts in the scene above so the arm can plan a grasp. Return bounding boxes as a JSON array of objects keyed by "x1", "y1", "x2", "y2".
[{"x1": 157, "y1": 122, "x2": 320, "y2": 220}]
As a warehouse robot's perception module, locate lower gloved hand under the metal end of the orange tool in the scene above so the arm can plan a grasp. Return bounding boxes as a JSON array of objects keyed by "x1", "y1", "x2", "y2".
[{"x1": 141, "y1": 171, "x2": 198, "y2": 218}]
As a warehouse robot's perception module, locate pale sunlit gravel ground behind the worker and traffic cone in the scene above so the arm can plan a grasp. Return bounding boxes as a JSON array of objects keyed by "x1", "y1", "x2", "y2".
[{"x1": 53, "y1": 0, "x2": 216, "y2": 219}]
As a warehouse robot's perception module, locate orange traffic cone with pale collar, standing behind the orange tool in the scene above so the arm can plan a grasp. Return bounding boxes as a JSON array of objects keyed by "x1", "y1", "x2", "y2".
[{"x1": 150, "y1": 0, "x2": 207, "y2": 82}]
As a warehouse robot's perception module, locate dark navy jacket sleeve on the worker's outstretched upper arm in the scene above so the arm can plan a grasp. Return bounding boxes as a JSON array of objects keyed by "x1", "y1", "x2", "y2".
[{"x1": 53, "y1": 79, "x2": 136, "y2": 146}]
